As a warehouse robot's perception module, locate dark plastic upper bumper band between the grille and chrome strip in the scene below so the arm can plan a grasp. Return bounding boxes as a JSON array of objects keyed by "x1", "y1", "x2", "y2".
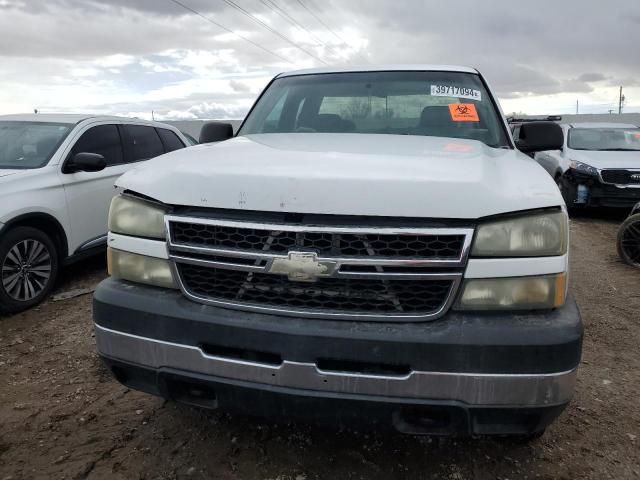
[{"x1": 93, "y1": 279, "x2": 583, "y2": 374}]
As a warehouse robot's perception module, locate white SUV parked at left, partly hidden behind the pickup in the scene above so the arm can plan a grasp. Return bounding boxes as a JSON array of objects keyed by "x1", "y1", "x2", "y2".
[{"x1": 0, "y1": 114, "x2": 188, "y2": 313}]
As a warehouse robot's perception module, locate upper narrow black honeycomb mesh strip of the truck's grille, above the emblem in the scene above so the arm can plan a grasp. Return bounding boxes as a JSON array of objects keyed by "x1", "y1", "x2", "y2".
[{"x1": 171, "y1": 222, "x2": 465, "y2": 259}]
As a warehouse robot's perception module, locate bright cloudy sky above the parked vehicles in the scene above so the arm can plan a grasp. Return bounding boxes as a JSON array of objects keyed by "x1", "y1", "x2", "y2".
[{"x1": 0, "y1": 0, "x2": 640, "y2": 119}]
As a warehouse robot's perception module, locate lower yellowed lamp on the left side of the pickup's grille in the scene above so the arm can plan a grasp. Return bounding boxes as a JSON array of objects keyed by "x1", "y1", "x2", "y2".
[{"x1": 107, "y1": 248, "x2": 178, "y2": 288}]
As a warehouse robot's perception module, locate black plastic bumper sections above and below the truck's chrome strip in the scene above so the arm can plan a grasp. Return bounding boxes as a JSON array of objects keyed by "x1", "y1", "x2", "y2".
[{"x1": 94, "y1": 279, "x2": 582, "y2": 434}]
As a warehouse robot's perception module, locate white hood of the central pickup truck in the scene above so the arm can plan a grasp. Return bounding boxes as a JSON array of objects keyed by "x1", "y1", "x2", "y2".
[{"x1": 117, "y1": 133, "x2": 563, "y2": 219}]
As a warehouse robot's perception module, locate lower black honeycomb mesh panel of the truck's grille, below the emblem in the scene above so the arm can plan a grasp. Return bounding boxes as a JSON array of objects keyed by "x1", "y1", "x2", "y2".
[{"x1": 178, "y1": 264, "x2": 453, "y2": 315}]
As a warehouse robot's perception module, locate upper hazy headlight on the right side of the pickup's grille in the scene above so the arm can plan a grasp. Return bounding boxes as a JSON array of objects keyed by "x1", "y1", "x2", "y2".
[{"x1": 471, "y1": 211, "x2": 568, "y2": 257}]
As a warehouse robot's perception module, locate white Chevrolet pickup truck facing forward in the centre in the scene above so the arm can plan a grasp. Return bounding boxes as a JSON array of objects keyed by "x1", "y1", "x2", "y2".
[{"x1": 94, "y1": 66, "x2": 583, "y2": 436}]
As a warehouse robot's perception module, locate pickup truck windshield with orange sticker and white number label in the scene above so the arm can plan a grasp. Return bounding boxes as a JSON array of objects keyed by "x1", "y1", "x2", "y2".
[{"x1": 239, "y1": 71, "x2": 510, "y2": 147}]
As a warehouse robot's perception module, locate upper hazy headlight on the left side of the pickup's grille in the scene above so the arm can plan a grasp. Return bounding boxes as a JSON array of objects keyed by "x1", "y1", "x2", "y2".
[{"x1": 109, "y1": 195, "x2": 166, "y2": 239}]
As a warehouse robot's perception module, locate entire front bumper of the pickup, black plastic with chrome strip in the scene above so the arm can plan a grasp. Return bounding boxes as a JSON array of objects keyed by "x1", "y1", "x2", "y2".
[{"x1": 94, "y1": 279, "x2": 582, "y2": 434}]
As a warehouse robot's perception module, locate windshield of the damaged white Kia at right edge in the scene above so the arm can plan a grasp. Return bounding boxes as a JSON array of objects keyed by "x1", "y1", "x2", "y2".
[{"x1": 567, "y1": 128, "x2": 640, "y2": 152}]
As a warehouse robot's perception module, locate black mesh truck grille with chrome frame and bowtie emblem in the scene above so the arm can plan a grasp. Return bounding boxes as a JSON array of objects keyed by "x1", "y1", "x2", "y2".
[{"x1": 166, "y1": 215, "x2": 473, "y2": 321}]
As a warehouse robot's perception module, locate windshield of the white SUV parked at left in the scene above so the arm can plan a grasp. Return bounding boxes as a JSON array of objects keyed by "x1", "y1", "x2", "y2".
[{"x1": 0, "y1": 122, "x2": 72, "y2": 169}]
